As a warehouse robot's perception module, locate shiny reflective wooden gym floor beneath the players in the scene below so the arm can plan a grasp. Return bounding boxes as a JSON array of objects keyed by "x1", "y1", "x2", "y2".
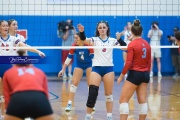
[{"x1": 48, "y1": 77, "x2": 180, "y2": 120}]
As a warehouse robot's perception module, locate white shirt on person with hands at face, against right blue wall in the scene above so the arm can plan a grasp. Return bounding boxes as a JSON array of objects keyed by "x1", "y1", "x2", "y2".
[{"x1": 149, "y1": 30, "x2": 163, "y2": 46}]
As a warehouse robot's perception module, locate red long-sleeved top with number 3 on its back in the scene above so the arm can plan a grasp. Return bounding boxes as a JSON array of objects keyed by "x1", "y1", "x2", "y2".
[{"x1": 122, "y1": 38, "x2": 151, "y2": 75}]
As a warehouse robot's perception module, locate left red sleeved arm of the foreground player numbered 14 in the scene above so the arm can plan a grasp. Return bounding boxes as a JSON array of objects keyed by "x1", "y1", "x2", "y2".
[{"x1": 3, "y1": 74, "x2": 11, "y2": 108}]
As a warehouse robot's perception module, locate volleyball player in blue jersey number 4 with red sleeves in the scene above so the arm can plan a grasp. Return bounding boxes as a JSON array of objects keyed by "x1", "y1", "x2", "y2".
[{"x1": 58, "y1": 33, "x2": 94, "y2": 111}]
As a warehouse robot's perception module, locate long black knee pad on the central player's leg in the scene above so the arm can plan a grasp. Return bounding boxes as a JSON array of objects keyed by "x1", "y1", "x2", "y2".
[{"x1": 86, "y1": 85, "x2": 99, "y2": 108}]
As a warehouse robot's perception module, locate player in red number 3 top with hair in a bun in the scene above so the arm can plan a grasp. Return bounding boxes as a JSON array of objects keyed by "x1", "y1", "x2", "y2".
[{"x1": 117, "y1": 20, "x2": 151, "y2": 120}]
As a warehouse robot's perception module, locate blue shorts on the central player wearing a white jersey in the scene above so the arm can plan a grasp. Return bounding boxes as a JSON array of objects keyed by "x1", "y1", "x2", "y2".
[{"x1": 92, "y1": 66, "x2": 114, "y2": 77}]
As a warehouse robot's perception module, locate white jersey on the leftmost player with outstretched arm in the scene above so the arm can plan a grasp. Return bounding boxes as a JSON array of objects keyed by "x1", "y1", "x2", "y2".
[{"x1": 0, "y1": 35, "x2": 20, "y2": 56}]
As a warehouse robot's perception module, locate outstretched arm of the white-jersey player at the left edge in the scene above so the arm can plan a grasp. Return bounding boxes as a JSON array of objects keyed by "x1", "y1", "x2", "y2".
[{"x1": 15, "y1": 40, "x2": 45, "y2": 57}]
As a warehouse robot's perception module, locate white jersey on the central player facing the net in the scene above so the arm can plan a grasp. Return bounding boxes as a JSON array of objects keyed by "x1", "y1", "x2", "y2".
[{"x1": 91, "y1": 37, "x2": 119, "y2": 66}]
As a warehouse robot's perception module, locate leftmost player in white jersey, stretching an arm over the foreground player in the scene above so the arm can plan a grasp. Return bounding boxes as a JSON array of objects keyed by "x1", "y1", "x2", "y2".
[{"x1": 0, "y1": 20, "x2": 45, "y2": 118}]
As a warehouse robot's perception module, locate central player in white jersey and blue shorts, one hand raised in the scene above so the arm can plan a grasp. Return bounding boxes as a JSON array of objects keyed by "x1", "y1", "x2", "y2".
[{"x1": 78, "y1": 21, "x2": 125, "y2": 120}]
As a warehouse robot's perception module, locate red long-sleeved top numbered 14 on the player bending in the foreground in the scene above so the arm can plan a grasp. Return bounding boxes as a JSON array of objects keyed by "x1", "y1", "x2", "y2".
[{"x1": 3, "y1": 66, "x2": 48, "y2": 107}]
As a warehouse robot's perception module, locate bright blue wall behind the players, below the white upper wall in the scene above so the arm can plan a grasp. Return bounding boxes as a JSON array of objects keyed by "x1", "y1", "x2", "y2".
[{"x1": 0, "y1": 16, "x2": 179, "y2": 74}]
